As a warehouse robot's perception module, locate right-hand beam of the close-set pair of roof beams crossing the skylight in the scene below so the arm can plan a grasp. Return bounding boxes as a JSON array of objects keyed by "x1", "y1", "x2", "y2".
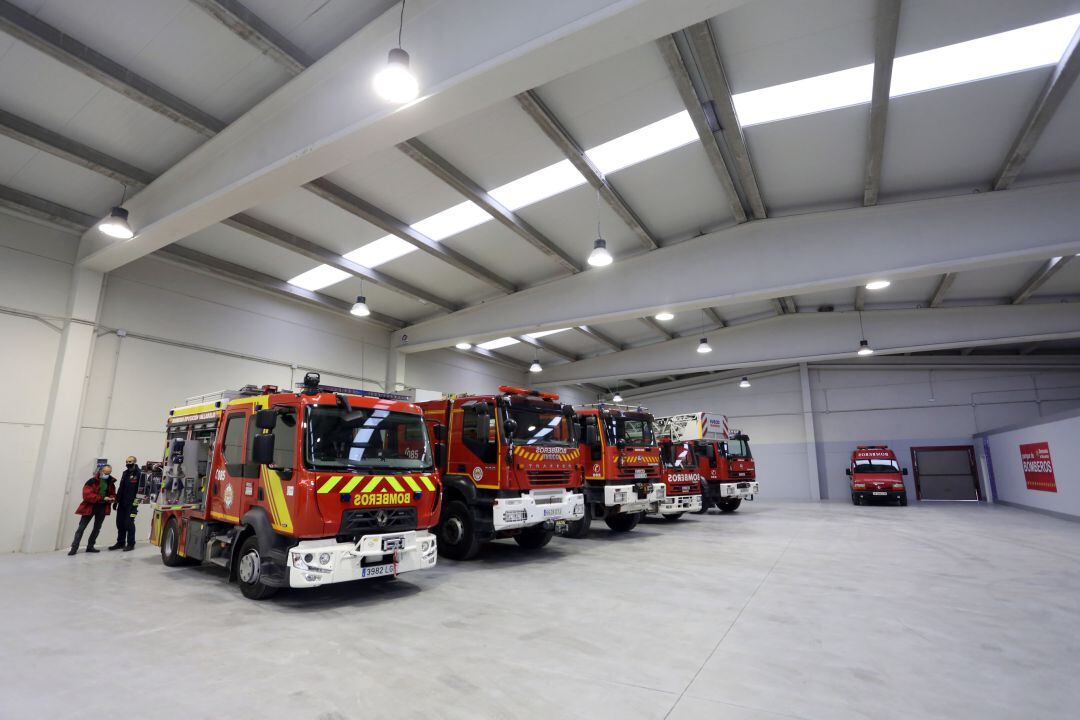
[{"x1": 684, "y1": 21, "x2": 769, "y2": 220}]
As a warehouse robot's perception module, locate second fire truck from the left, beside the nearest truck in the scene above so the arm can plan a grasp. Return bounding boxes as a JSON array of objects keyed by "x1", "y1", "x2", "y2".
[{"x1": 419, "y1": 385, "x2": 584, "y2": 560}]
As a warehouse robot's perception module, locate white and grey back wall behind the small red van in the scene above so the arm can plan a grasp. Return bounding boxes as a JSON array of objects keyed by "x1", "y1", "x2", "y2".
[{"x1": 633, "y1": 366, "x2": 1080, "y2": 501}]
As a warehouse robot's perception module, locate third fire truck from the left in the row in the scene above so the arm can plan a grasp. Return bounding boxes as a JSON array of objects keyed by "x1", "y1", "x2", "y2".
[{"x1": 567, "y1": 404, "x2": 664, "y2": 538}]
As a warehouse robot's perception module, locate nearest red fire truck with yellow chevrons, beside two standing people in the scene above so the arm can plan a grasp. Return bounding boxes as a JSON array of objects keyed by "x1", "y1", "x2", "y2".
[{"x1": 150, "y1": 372, "x2": 441, "y2": 600}]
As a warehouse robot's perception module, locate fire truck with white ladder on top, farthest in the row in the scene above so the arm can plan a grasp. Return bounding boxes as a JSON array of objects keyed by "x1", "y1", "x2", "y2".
[{"x1": 657, "y1": 412, "x2": 759, "y2": 513}]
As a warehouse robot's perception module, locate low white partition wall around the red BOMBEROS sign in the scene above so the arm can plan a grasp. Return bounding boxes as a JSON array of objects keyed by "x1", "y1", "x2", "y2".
[{"x1": 986, "y1": 413, "x2": 1080, "y2": 518}]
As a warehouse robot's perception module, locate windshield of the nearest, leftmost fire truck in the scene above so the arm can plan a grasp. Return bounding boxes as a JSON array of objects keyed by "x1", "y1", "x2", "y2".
[{"x1": 305, "y1": 406, "x2": 431, "y2": 471}]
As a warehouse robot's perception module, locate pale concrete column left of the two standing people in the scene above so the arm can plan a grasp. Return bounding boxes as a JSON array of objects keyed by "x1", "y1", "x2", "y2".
[{"x1": 22, "y1": 267, "x2": 105, "y2": 553}]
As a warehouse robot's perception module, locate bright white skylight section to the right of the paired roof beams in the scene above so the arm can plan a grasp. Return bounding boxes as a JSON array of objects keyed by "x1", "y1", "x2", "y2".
[{"x1": 732, "y1": 14, "x2": 1080, "y2": 127}]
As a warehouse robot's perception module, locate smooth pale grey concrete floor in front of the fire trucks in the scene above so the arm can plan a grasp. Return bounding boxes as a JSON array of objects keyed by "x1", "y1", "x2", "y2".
[{"x1": 0, "y1": 501, "x2": 1080, "y2": 720}]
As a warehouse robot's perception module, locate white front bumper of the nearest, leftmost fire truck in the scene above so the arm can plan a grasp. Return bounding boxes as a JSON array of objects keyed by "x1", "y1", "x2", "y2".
[{"x1": 286, "y1": 530, "x2": 436, "y2": 587}]
